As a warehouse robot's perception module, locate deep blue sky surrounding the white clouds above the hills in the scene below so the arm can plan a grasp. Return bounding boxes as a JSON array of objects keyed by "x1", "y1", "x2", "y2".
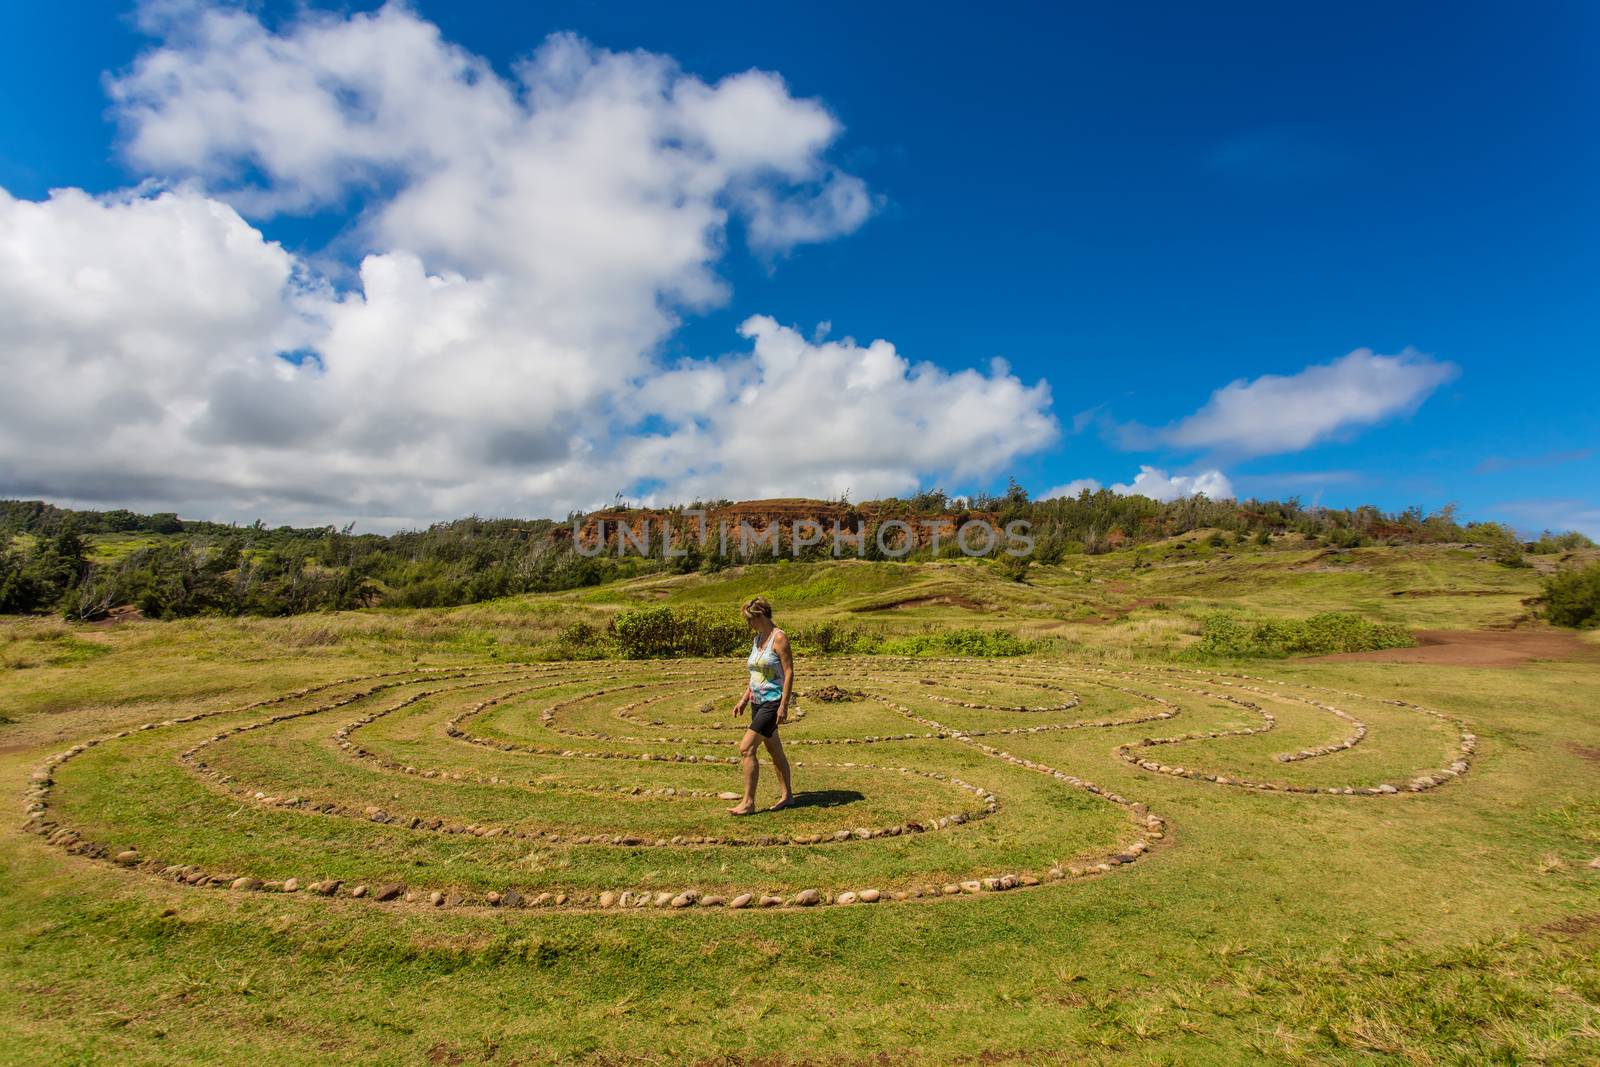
[{"x1": 0, "y1": 3, "x2": 1600, "y2": 536}]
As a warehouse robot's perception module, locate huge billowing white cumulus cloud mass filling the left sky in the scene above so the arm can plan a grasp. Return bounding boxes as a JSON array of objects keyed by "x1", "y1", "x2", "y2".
[{"x1": 0, "y1": 3, "x2": 1058, "y2": 526}]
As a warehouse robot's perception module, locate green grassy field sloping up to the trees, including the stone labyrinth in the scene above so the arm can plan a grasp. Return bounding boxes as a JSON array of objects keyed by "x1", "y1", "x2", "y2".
[{"x1": 0, "y1": 536, "x2": 1600, "y2": 1064}]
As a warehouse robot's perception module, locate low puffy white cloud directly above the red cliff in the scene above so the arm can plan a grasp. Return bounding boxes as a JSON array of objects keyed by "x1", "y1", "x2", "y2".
[{"x1": 627, "y1": 315, "x2": 1059, "y2": 498}]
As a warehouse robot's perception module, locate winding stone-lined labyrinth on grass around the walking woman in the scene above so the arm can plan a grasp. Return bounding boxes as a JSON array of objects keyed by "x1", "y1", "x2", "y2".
[{"x1": 24, "y1": 657, "x2": 1475, "y2": 909}]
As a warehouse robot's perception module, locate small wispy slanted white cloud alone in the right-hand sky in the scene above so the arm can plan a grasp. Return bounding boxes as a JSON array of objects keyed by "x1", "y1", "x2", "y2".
[{"x1": 1145, "y1": 349, "x2": 1458, "y2": 456}]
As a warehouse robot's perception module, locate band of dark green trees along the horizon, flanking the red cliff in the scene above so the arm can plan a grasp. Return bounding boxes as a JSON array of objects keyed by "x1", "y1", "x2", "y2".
[{"x1": 0, "y1": 482, "x2": 1594, "y2": 621}]
